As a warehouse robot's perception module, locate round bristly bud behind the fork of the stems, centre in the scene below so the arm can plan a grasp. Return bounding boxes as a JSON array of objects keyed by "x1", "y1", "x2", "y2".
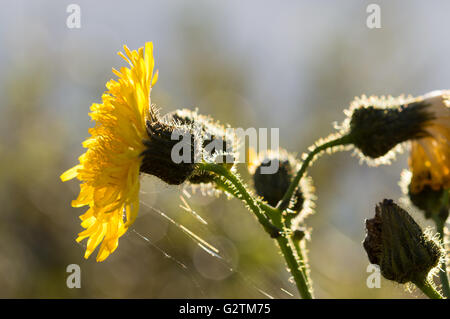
[{"x1": 248, "y1": 149, "x2": 315, "y2": 228}]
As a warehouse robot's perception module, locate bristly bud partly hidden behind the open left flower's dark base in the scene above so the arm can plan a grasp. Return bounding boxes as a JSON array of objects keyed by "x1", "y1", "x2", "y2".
[{"x1": 165, "y1": 109, "x2": 238, "y2": 188}]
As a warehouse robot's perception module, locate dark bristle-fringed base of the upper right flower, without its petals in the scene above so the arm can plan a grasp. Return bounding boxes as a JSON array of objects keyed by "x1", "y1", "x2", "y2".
[{"x1": 336, "y1": 95, "x2": 433, "y2": 165}]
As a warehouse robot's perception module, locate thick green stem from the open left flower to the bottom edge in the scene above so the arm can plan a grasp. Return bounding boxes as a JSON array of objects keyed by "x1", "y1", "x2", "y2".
[{"x1": 202, "y1": 163, "x2": 312, "y2": 299}]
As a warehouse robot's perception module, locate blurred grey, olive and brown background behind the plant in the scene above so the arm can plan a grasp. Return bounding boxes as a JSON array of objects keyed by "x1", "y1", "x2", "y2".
[{"x1": 0, "y1": 0, "x2": 450, "y2": 298}]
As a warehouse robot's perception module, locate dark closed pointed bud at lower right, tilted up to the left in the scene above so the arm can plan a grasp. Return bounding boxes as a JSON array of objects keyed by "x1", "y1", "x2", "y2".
[{"x1": 363, "y1": 199, "x2": 444, "y2": 284}]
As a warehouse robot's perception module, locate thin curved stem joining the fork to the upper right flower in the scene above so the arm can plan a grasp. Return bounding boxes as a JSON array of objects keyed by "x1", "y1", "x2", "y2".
[{"x1": 277, "y1": 135, "x2": 351, "y2": 211}]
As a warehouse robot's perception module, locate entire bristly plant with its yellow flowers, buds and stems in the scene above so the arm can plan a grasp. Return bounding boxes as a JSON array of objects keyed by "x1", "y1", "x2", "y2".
[{"x1": 61, "y1": 43, "x2": 450, "y2": 298}]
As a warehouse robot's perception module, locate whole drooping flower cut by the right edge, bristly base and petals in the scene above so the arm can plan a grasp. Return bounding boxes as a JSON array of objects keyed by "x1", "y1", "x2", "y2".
[{"x1": 339, "y1": 91, "x2": 450, "y2": 168}]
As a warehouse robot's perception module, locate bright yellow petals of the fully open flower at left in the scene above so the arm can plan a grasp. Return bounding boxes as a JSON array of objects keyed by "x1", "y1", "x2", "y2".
[{"x1": 61, "y1": 42, "x2": 158, "y2": 261}]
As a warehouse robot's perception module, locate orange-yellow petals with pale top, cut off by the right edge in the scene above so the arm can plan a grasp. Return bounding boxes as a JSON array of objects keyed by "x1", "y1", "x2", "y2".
[{"x1": 409, "y1": 91, "x2": 450, "y2": 193}]
